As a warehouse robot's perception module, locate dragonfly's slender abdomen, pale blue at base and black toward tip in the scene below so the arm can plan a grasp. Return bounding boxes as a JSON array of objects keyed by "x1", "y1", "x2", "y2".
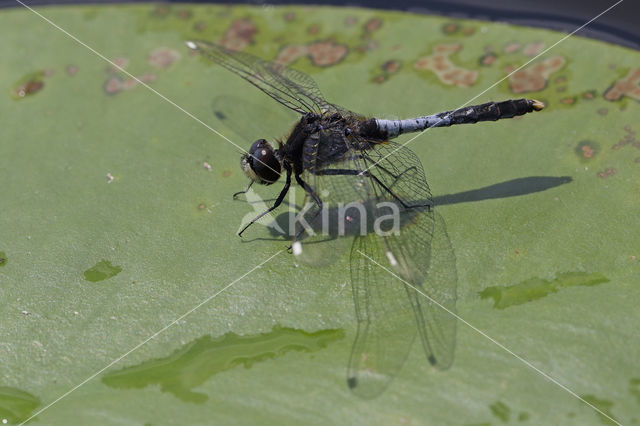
[{"x1": 373, "y1": 99, "x2": 544, "y2": 138}]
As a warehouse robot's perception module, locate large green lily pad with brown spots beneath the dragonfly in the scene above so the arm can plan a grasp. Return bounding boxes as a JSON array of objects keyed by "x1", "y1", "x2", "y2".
[{"x1": 0, "y1": 4, "x2": 640, "y2": 425}]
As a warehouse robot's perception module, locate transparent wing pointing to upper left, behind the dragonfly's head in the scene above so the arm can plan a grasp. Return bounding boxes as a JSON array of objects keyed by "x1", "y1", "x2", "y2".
[{"x1": 187, "y1": 40, "x2": 343, "y2": 114}]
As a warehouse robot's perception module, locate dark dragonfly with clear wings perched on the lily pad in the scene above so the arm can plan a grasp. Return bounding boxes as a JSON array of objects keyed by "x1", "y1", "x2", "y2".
[{"x1": 186, "y1": 41, "x2": 544, "y2": 398}]
